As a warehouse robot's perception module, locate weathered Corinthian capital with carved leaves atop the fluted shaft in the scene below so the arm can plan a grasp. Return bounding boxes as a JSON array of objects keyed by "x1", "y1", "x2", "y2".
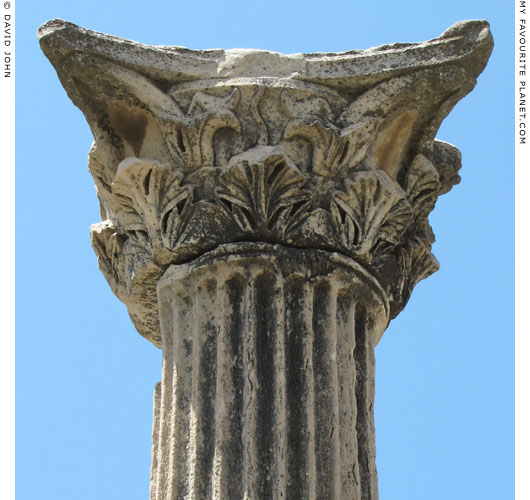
[{"x1": 40, "y1": 20, "x2": 492, "y2": 345}]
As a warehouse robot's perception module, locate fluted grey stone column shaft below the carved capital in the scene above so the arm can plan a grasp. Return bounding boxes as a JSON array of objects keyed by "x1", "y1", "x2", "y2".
[{"x1": 151, "y1": 244, "x2": 388, "y2": 500}]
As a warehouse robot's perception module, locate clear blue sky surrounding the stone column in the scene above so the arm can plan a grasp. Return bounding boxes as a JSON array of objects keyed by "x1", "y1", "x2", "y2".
[{"x1": 16, "y1": 0, "x2": 514, "y2": 500}]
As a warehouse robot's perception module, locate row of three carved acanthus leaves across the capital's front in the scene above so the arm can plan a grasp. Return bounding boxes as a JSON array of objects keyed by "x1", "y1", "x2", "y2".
[{"x1": 99, "y1": 146, "x2": 428, "y2": 262}]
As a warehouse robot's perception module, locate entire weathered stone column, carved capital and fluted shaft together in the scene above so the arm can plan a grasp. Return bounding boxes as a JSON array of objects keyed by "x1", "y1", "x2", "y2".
[{"x1": 39, "y1": 20, "x2": 493, "y2": 500}]
